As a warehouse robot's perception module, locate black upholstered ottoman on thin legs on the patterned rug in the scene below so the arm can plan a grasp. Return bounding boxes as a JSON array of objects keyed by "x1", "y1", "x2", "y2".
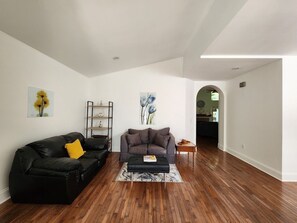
[{"x1": 127, "y1": 156, "x2": 170, "y2": 182}]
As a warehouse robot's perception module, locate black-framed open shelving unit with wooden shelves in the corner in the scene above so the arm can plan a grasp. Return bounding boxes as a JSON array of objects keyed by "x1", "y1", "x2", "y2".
[{"x1": 86, "y1": 101, "x2": 113, "y2": 151}]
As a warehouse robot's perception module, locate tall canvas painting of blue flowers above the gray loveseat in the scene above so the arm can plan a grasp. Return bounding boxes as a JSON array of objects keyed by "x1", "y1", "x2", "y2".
[{"x1": 140, "y1": 92, "x2": 157, "y2": 125}]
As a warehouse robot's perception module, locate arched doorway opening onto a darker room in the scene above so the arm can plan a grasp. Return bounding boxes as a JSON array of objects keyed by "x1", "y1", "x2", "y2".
[{"x1": 196, "y1": 85, "x2": 225, "y2": 150}]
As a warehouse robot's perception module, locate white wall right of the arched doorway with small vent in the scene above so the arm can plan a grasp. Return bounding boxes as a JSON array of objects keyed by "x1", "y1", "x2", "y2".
[{"x1": 226, "y1": 60, "x2": 282, "y2": 179}]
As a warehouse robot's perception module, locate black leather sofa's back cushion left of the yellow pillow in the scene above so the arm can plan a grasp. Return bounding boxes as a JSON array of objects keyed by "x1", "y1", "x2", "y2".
[{"x1": 27, "y1": 136, "x2": 68, "y2": 158}]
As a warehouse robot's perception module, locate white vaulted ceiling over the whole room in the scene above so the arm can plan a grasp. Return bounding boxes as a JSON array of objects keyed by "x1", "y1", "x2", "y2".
[{"x1": 0, "y1": 0, "x2": 297, "y2": 80}]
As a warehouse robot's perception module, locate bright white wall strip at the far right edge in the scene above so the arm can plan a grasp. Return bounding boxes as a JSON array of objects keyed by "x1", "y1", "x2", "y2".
[{"x1": 282, "y1": 57, "x2": 297, "y2": 181}]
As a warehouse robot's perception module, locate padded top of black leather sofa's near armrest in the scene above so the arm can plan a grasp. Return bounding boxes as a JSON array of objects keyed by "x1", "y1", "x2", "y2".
[{"x1": 32, "y1": 157, "x2": 82, "y2": 172}]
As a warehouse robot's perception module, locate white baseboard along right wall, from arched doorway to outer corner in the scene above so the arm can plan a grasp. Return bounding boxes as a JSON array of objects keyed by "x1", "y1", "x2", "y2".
[{"x1": 226, "y1": 148, "x2": 283, "y2": 181}]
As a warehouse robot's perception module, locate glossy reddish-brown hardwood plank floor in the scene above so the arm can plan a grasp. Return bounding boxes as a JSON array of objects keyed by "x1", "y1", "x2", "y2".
[{"x1": 0, "y1": 139, "x2": 297, "y2": 223}]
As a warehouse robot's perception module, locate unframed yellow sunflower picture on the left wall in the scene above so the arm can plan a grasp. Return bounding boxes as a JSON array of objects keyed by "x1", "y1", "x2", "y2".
[{"x1": 28, "y1": 87, "x2": 54, "y2": 118}]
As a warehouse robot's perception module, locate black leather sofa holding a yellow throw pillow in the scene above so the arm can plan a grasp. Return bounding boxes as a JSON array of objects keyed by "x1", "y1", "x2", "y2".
[{"x1": 9, "y1": 132, "x2": 108, "y2": 204}]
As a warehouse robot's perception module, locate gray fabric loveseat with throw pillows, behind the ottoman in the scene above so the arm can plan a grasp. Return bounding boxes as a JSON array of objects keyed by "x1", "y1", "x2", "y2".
[{"x1": 120, "y1": 128, "x2": 176, "y2": 163}]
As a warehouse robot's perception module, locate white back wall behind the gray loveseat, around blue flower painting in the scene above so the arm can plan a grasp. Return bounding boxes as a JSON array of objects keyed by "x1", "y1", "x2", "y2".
[{"x1": 89, "y1": 58, "x2": 194, "y2": 151}]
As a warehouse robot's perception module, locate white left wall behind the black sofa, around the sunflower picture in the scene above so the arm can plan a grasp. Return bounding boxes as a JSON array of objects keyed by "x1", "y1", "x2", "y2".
[{"x1": 0, "y1": 32, "x2": 87, "y2": 203}]
